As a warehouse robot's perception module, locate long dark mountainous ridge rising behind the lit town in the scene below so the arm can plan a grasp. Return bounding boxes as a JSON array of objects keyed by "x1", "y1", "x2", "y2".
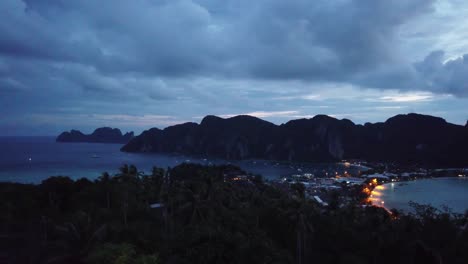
[{"x1": 121, "y1": 113, "x2": 468, "y2": 167}]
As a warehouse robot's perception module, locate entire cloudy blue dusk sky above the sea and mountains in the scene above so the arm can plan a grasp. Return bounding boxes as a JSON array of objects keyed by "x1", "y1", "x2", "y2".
[{"x1": 0, "y1": 0, "x2": 468, "y2": 135}]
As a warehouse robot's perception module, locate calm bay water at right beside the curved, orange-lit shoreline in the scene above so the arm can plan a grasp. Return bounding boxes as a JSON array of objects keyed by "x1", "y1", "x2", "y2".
[{"x1": 379, "y1": 177, "x2": 468, "y2": 213}]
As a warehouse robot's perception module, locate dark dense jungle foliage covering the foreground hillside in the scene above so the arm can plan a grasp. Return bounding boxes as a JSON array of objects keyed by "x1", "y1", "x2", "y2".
[{"x1": 0, "y1": 164, "x2": 468, "y2": 264}]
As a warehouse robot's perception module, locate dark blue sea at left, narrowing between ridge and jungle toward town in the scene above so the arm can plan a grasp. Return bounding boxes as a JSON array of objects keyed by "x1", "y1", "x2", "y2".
[{"x1": 0, "y1": 137, "x2": 360, "y2": 183}]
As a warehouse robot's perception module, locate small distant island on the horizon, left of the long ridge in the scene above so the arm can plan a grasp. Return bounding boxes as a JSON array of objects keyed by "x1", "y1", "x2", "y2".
[{"x1": 56, "y1": 127, "x2": 134, "y2": 144}]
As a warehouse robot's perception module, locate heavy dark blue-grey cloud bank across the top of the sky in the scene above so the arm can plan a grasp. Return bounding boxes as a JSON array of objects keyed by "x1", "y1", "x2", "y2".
[{"x1": 0, "y1": 0, "x2": 433, "y2": 81}]
